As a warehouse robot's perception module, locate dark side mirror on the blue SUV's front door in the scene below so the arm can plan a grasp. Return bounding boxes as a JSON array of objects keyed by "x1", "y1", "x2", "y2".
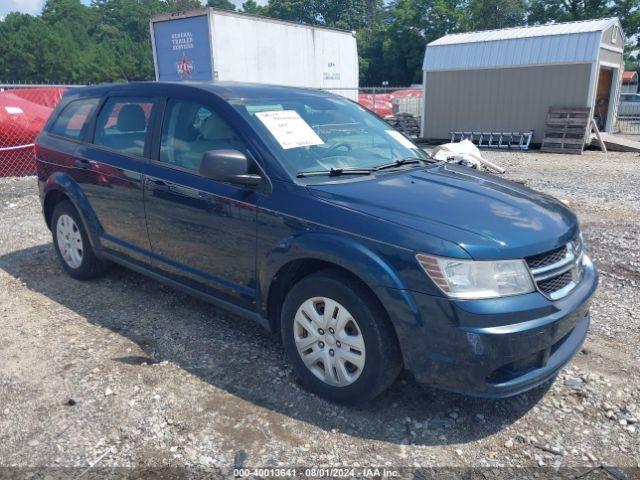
[{"x1": 199, "y1": 150, "x2": 262, "y2": 187}]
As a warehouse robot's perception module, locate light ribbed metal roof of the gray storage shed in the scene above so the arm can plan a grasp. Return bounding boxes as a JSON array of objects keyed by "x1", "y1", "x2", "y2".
[{"x1": 423, "y1": 17, "x2": 622, "y2": 72}]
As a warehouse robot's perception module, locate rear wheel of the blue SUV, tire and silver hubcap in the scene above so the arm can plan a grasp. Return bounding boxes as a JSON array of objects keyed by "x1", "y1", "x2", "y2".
[{"x1": 51, "y1": 200, "x2": 107, "y2": 280}]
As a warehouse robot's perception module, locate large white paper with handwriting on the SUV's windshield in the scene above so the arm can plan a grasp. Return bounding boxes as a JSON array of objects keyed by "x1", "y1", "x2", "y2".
[{"x1": 256, "y1": 110, "x2": 324, "y2": 150}]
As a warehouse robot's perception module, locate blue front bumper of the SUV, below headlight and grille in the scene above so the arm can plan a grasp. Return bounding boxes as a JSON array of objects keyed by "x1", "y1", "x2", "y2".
[{"x1": 384, "y1": 256, "x2": 598, "y2": 398}]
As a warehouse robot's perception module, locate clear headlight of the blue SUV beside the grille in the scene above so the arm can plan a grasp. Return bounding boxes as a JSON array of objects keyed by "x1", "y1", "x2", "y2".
[{"x1": 416, "y1": 254, "x2": 535, "y2": 300}]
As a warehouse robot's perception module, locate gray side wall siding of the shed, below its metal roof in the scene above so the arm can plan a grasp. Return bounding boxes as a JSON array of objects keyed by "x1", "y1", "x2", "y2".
[{"x1": 422, "y1": 64, "x2": 591, "y2": 143}]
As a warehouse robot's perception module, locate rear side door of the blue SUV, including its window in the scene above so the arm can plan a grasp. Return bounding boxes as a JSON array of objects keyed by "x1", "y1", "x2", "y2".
[{"x1": 75, "y1": 96, "x2": 160, "y2": 266}]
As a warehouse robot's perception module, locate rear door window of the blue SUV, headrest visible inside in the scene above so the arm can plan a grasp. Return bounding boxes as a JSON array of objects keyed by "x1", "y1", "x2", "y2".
[{"x1": 93, "y1": 97, "x2": 153, "y2": 156}]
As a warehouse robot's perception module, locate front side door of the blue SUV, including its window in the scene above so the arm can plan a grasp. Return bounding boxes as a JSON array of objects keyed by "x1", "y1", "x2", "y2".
[{"x1": 144, "y1": 99, "x2": 259, "y2": 309}]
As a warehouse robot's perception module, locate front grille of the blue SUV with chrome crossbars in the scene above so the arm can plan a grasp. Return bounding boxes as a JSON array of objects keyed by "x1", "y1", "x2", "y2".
[{"x1": 525, "y1": 237, "x2": 583, "y2": 300}]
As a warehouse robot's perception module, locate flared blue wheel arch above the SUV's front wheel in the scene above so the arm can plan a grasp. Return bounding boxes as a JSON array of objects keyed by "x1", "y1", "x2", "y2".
[{"x1": 258, "y1": 232, "x2": 422, "y2": 334}]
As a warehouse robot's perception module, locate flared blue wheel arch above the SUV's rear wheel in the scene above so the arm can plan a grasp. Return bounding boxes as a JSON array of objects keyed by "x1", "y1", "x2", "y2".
[{"x1": 40, "y1": 172, "x2": 102, "y2": 249}]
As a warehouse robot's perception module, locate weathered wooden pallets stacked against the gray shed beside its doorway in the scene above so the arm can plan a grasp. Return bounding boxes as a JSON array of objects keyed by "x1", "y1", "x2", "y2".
[{"x1": 540, "y1": 107, "x2": 591, "y2": 155}]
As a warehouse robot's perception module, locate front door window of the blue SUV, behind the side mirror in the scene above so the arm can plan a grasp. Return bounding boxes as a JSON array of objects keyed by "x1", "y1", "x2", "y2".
[{"x1": 160, "y1": 99, "x2": 246, "y2": 171}]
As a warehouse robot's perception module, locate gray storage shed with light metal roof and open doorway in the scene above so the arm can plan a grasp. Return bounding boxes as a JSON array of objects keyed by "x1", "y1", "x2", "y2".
[{"x1": 422, "y1": 18, "x2": 624, "y2": 143}]
